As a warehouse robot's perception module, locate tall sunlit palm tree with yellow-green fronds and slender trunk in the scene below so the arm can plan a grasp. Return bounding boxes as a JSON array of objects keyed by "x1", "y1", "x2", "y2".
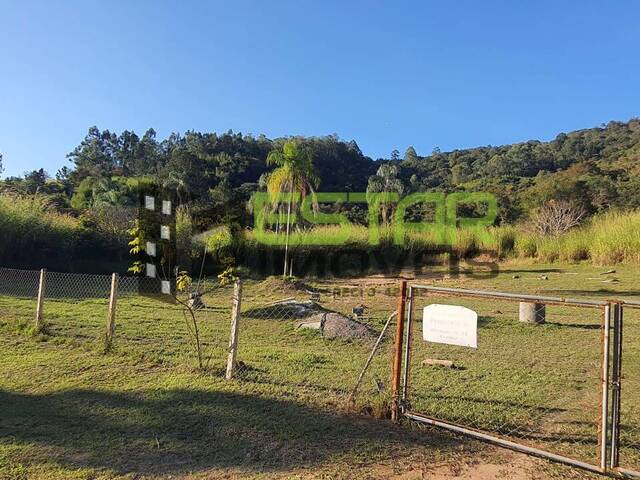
[{"x1": 266, "y1": 139, "x2": 320, "y2": 278}]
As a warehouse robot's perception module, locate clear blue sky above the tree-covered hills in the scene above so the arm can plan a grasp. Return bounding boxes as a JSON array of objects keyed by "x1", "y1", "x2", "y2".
[{"x1": 0, "y1": 0, "x2": 640, "y2": 176}]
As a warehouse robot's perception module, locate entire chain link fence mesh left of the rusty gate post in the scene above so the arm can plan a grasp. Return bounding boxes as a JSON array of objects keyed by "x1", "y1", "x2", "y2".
[{"x1": 0, "y1": 268, "x2": 398, "y2": 415}]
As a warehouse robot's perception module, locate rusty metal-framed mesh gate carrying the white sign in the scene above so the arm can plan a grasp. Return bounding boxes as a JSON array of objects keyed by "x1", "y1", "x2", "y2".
[{"x1": 394, "y1": 284, "x2": 640, "y2": 476}]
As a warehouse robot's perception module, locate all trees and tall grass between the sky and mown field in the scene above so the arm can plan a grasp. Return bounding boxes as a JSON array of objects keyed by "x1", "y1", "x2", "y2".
[{"x1": 0, "y1": 119, "x2": 640, "y2": 268}]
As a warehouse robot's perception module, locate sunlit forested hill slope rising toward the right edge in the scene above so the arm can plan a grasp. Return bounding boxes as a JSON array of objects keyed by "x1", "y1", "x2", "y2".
[{"x1": 398, "y1": 119, "x2": 640, "y2": 220}]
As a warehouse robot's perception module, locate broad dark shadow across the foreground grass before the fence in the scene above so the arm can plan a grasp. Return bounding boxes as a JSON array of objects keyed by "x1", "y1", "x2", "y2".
[{"x1": 0, "y1": 390, "x2": 461, "y2": 475}]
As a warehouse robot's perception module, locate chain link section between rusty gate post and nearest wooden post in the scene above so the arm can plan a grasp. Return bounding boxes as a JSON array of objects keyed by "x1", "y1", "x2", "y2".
[{"x1": 229, "y1": 277, "x2": 397, "y2": 410}]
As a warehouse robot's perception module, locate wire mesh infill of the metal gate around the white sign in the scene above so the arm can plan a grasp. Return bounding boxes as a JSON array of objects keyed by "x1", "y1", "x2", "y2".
[{"x1": 406, "y1": 289, "x2": 602, "y2": 465}]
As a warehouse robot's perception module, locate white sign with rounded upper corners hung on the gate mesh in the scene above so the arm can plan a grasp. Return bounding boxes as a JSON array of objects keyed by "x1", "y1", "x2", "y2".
[{"x1": 422, "y1": 303, "x2": 478, "y2": 348}]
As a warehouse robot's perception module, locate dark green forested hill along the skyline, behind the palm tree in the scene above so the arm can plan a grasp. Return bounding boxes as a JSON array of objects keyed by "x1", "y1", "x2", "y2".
[{"x1": 0, "y1": 119, "x2": 640, "y2": 227}]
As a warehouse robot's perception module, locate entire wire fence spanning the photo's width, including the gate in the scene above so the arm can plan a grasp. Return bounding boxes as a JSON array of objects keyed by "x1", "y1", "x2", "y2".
[{"x1": 0, "y1": 268, "x2": 640, "y2": 475}]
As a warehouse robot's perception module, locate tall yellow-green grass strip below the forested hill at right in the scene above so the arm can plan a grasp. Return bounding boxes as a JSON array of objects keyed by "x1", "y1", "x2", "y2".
[{"x1": 230, "y1": 211, "x2": 640, "y2": 272}]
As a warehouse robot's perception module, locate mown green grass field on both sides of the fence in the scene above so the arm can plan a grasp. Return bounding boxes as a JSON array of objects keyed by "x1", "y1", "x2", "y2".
[{"x1": 0, "y1": 264, "x2": 640, "y2": 479}]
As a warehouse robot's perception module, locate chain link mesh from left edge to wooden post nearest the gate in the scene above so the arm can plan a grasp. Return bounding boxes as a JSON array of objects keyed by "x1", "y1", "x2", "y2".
[{"x1": 0, "y1": 268, "x2": 231, "y2": 368}]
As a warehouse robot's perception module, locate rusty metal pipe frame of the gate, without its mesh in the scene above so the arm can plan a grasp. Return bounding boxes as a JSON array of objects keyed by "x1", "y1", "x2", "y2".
[{"x1": 393, "y1": 281, "x2": 624, "y2": 476}]
